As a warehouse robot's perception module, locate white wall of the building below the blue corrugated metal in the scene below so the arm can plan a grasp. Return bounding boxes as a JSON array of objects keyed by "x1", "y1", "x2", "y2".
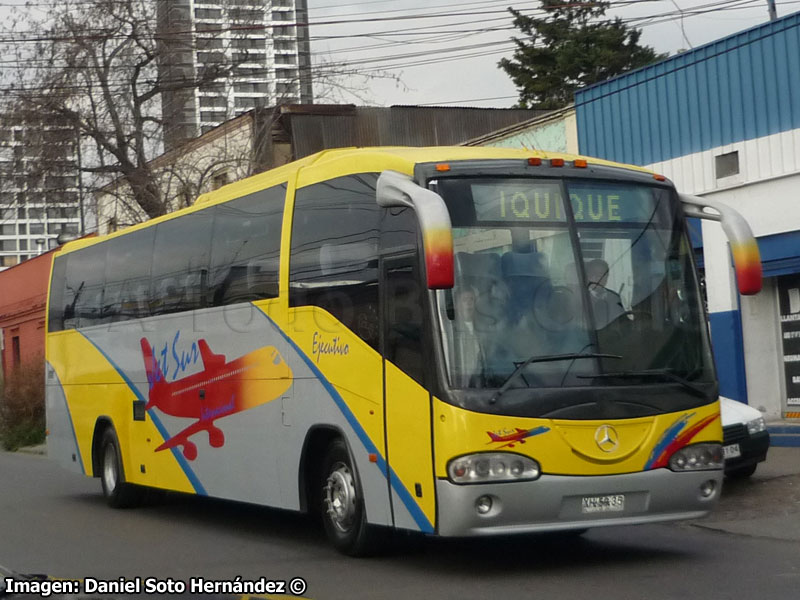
[{"x1": 647, "y1": 130, "x2": 800, "y2": 418}]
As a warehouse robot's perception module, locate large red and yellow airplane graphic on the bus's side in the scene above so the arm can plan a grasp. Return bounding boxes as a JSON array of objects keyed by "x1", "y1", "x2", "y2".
[{"x1": 141, "y1": 338, "x2": 292, "y2": 460}]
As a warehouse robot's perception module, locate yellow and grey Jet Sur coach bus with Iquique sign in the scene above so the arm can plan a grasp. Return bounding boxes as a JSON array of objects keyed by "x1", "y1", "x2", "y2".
[{"x1": 46, "y1": 147, "x2": 761, "y2": 554}]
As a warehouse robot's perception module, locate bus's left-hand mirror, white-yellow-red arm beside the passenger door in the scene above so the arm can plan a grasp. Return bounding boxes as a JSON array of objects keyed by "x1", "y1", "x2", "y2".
[{"x1": 376, "y1": 171, "x2": 455, "y2": 290}]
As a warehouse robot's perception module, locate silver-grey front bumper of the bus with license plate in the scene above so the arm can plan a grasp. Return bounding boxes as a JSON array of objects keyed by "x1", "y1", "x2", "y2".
[{"x1": 436, "y1": 469, "x2": 723, "y2": 536}]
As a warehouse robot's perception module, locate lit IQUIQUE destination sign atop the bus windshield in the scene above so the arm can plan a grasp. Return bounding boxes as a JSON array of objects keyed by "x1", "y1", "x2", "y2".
[{"x1": 470, "y1": 179, "x2": 667, "y2": 224}]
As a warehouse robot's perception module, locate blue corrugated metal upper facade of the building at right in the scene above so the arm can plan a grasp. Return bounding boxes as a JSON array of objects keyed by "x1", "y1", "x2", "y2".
[{"x1": 575, "y1": 13, "x2": 800, "y2": 165}]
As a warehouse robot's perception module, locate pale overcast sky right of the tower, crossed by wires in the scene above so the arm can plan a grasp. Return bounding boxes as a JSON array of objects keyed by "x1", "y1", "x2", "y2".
[{"x1": 308, "y1": 0, "x2": 800, "y2": 107}]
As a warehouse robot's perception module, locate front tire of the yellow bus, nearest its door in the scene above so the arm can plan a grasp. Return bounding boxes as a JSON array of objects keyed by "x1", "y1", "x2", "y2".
[{"x1": 320, "y1": 438, "x2": 375, "y2": 556}]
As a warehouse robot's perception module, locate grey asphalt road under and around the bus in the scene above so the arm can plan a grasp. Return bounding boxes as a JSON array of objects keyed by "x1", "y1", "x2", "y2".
[{"x1": 0, "y1": 449, "x2": 800, "y2": 600}]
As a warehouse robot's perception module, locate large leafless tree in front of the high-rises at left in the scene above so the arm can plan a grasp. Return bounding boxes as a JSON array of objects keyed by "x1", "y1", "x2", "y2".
[{"x1": 0, "y1": 0, "x2": 396, "y2": 231}]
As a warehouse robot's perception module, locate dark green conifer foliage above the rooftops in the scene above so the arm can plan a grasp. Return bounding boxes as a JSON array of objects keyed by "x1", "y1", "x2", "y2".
[{"x1": 499, "y1": 0, "x2": 666, "y2": 109}]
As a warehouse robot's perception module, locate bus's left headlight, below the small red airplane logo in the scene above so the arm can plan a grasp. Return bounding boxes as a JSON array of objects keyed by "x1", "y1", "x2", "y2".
[{"x1": 447, "y1": 452, "x2": 541, "y2": 483}]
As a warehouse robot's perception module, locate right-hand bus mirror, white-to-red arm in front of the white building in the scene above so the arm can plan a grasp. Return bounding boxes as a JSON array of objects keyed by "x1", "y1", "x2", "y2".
[{"x1": 679, "y1": 194, "x2": 762, "y2": 296}]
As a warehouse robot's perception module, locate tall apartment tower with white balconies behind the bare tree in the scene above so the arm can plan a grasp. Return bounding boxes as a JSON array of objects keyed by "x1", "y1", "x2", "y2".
[{"x1": 157, "y1": 0, "x2": 312, "y2": 150}]
